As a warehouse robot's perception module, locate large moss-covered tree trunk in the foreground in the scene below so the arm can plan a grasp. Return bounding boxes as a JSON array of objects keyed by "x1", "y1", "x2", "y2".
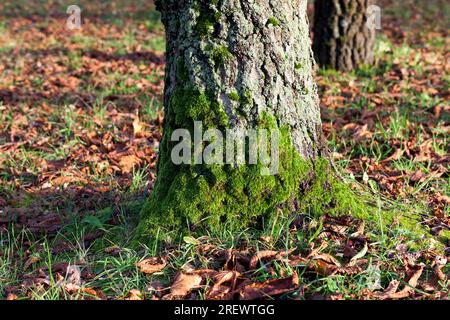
[{"x1": 138, "y1": 0, "x2": 358, "y2": 239}]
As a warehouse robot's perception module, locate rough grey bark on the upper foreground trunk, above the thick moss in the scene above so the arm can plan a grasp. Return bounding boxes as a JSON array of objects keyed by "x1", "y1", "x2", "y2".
[{"x1": 160, "y1": 0, "x2": 321, "y2": 158}]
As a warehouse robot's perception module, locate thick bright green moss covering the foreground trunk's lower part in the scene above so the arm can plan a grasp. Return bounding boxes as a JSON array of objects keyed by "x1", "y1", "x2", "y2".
[{"x1": 138, "y1": 94, "x2": 370, "y2": 237}]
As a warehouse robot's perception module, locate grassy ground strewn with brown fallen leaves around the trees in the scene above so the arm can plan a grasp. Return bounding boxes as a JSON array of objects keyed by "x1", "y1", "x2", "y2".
[{"x1": 0, "y1": 0, "x2": 450, "y2": 299}]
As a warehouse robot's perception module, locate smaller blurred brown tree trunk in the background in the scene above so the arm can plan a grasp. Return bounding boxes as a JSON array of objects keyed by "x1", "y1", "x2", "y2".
[{"x1": 313, "y1": 0, "x2": 375, "y2": 72}]
